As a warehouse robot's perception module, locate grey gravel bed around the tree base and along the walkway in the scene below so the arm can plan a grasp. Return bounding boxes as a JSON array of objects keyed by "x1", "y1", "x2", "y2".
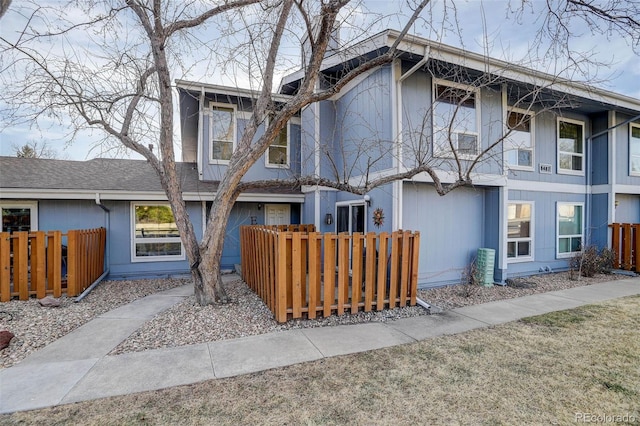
[{"x1": 0, "y1": 273, "x2": 626, "y2": 368}]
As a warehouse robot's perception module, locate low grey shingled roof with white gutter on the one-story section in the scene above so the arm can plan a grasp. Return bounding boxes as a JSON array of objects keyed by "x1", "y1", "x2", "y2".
[{"x1": 0, "y1": 156, "x2": 303, "y2": 202}]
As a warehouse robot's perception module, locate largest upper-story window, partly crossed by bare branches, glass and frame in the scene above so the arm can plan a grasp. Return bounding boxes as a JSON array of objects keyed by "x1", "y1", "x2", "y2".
[{"x1": 433, "y1": 80, "x2": 480, "y2": 158}]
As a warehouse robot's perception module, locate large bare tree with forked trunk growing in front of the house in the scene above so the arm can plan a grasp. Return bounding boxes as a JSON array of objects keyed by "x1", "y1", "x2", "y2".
[{"x1": 0, "y1": 0, "x2": 636, "y2": 304}]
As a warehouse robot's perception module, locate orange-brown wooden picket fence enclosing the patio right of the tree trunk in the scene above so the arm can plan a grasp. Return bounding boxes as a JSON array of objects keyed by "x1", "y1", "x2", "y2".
[{"x1": 240, "y1": 225, "x2": 420, "y2": 322}]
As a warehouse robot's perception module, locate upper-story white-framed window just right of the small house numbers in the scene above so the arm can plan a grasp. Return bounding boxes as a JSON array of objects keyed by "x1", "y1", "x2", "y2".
[{"x1": 558, "y1": 118, "x2": 584, "y2": 175}]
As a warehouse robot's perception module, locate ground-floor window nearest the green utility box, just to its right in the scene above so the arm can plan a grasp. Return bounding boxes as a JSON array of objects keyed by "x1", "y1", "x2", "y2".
[{"x1": 507, "y1": 202, "x2": 533, "y2": 261}]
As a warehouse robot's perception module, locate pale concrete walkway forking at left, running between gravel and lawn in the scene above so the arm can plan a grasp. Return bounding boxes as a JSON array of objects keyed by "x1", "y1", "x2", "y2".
[{"x1": 0, "y1": 277, "x2": 640, "y2": 413}]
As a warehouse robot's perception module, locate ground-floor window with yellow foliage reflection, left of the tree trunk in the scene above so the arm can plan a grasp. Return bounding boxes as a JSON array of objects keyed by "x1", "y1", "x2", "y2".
[{"x1": 131, "y1": 204, "x2": 184, "y2": 262}]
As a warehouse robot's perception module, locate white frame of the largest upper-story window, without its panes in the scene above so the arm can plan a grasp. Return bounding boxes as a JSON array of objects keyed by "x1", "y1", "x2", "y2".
[{"x1": 431, "y1": 78, "x2": 482, "y2": 160}]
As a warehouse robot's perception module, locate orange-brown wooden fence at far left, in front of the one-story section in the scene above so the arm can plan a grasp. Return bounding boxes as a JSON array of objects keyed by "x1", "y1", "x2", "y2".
[{"x1": 0, "y1": 228, "x2": 107, "y2": 302}]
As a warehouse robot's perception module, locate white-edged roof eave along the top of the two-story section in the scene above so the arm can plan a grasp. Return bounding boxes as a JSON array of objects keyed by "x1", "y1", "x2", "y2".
[{"x1": 280, "y1": 30, "x2": 640, "y2": 113}]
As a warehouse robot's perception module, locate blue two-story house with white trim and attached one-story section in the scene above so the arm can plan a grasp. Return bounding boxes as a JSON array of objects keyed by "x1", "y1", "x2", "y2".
[{"x1": 0, "y1": 30, "x2": 640, "y2": 287}]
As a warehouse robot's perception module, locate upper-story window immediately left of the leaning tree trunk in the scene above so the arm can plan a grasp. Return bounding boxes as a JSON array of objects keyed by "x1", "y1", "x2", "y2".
[{"x1": 209, "y1": 103, "x2": 236, "y2": 164}]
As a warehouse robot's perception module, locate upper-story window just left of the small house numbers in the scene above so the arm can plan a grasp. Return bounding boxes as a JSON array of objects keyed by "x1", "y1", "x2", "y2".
[{"x1": 504, "y1": 108, "x2": 535, "y2": 170}]
